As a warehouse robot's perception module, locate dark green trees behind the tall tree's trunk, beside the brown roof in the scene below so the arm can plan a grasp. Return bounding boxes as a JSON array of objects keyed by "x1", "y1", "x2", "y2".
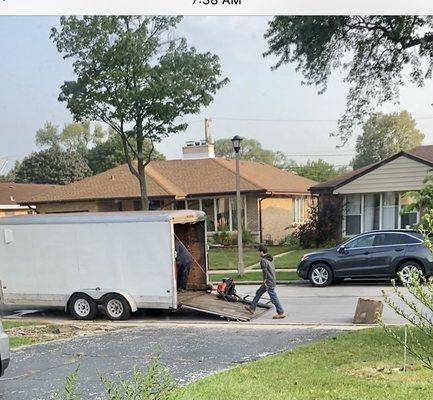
[{"x1": 86, "y1": 130, "x2": 165, "y2": 174}]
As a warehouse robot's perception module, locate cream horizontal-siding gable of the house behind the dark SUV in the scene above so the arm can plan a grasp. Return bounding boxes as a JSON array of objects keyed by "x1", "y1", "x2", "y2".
[{"x1": 333, "y1": 153, "x2": 432, "y2": 194}]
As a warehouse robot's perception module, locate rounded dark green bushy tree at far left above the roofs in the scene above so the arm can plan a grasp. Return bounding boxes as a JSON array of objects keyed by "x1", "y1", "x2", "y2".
[{"x1": 14, "y1": 146, "x2": 92, "y2": 185}]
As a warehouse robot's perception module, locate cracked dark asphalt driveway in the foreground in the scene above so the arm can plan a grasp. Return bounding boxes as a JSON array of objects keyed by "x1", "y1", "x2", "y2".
[{"x1": 0, "y1": 324, "x2": 336, "y2": 400}]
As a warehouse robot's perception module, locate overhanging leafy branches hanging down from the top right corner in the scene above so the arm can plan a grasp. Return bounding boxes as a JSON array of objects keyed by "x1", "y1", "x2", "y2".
[{"x1": 265, "y1": 15, "x2": 433, "y2": 142}]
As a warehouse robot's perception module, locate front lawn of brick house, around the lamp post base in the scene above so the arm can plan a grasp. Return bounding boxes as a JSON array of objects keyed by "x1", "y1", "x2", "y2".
[{"x1": 209, "y1": 246, "x2": 288, "y2": 269}]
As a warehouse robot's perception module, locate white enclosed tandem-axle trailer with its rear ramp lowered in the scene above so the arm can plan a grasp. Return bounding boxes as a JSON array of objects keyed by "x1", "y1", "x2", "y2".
[{"x1": 0, "y1": 210, "x2": 262, "y2": 320}]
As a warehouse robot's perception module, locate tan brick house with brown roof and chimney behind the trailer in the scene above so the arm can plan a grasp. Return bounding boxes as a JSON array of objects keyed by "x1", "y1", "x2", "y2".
[{"x1": 21, "y1": 143, "x2": 316, "y2": 242}]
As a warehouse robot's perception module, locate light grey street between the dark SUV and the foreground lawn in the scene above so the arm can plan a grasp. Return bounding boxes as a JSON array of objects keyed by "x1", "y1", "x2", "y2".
[{"x1": 3, "y1": 281, "x2": 405, "y2": 326}]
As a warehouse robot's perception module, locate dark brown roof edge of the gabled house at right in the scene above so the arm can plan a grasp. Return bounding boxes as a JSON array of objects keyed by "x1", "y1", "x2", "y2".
[{"x1": 310, "y1": 145, "x2": 433, "y2": 194}]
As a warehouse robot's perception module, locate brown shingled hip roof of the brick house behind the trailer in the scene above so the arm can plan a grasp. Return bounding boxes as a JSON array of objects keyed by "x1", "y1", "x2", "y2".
[{"x1": 22, "y1": 158, "x2": 316, "y2": 204}]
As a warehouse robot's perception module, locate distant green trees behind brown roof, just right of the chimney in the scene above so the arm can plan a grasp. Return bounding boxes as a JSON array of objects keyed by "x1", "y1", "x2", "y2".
[{"x1": 215, "y1": 138, "x2": 290, "y2": 168}]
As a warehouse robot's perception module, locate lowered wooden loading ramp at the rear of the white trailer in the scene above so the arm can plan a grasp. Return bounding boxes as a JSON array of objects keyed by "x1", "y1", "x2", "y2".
[{"x1": 177, "y1": 291, "x2": 267, "y2": 321}]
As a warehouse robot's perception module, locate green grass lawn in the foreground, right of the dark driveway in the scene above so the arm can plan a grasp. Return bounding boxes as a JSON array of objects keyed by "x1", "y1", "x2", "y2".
[{"x1": 179, "y1": 328, "x2": 433, "y2": 400}]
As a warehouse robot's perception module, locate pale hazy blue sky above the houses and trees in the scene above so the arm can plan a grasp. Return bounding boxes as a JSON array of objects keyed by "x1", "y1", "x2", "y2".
[{"x1": 0, "y1": 16, "x2": 433, "y2": 171}]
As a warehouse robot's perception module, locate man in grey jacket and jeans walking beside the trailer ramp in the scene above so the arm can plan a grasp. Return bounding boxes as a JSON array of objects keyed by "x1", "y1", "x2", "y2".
[{"x1": 245, "y1": 245, "x2": 286, "y2": 319}]
